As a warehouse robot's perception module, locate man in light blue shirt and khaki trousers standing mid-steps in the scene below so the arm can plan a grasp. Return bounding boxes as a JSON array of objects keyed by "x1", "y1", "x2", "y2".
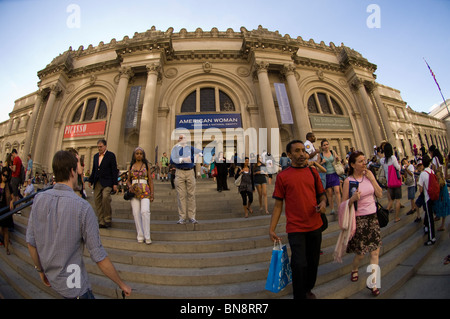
[{"x1": 170, "y1": 134, "x2": 203, "y2": 224}]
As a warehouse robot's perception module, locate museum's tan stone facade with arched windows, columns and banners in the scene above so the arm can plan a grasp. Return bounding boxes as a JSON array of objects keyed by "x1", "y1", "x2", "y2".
[{"x1": 0, "y1": 26, "x2": 447, "y2": 171}]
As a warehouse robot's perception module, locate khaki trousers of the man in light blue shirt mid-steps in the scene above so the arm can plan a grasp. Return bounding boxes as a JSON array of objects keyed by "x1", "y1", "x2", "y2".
[{"x1": 175, "y1": 169, "x2": 196, "y2": 220}]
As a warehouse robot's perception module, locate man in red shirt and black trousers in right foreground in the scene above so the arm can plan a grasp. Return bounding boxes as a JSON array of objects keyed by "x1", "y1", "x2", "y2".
[{"x1": 269, "y1": 140, "x2": 326, "y2": 299}]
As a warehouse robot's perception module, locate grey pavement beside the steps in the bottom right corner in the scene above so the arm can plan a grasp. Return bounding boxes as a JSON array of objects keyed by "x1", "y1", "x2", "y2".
[{"x1": 388, "y1": 225, "x2": 450, "y2": 299}]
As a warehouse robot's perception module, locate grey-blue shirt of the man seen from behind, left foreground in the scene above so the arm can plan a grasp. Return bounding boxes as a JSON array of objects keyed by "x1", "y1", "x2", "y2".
[{"x1": 26, "y1": 184, "x2": 107, "y2": 298}]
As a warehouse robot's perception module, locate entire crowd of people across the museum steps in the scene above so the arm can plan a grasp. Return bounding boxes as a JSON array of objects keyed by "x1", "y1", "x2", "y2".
[{"x1": 0, "y1": 133, "x2": 450, "y2": 298}]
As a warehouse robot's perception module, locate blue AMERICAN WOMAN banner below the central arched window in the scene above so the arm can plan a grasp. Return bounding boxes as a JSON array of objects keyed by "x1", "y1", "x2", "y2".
[{"x1": 175, "y1": 113, "x2": 242, "y2": 130}]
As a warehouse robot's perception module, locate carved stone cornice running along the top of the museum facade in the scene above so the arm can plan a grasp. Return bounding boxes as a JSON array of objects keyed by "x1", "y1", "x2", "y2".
[{"x1": 38, "y1": 26, "x2": 376, "y2": 79}]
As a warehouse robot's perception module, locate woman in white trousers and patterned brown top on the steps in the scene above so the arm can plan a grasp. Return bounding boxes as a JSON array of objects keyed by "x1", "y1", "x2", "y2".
[{"x1": 127, "y1": 147, "x2": 153, "y2": 244}]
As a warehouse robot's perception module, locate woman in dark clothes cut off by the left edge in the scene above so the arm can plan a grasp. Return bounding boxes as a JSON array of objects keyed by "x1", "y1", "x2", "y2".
[{"x1": 0, "y1": 167, "x2": 14, "y2": 255}]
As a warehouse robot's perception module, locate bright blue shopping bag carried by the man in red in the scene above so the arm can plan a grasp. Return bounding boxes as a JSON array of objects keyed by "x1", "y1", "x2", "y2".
[{"x1": 266, "y1": 241, "x2": 292, "y2": 293}]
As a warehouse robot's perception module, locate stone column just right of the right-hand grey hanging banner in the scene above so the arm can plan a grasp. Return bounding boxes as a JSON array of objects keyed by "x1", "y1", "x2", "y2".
[{"x1": 283, "y1": 64, "x2": 312, "y2": 140}]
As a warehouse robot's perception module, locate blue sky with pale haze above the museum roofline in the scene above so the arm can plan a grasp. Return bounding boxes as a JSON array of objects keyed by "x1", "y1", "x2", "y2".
[{"x1": 0, "y1": 0, "x2": 450, "y2": 122}]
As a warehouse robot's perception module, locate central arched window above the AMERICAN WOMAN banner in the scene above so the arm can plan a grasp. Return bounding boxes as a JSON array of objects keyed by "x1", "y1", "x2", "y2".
[{"x1": 181, "y1": 87, "x2": 236, "y2": 113}]
